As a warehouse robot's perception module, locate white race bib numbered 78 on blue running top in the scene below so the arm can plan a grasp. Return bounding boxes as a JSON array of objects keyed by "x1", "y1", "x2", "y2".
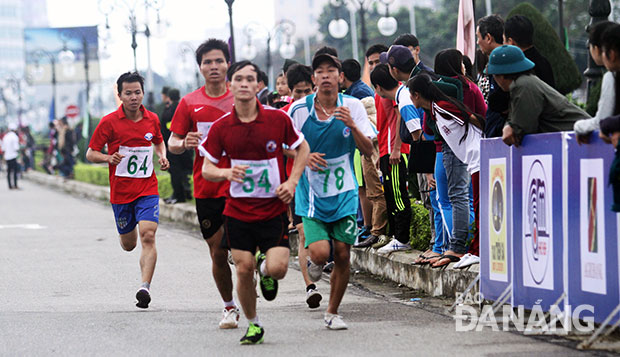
[{"x1": 306, "y1": 154, "x2": 355, "y2": 197}]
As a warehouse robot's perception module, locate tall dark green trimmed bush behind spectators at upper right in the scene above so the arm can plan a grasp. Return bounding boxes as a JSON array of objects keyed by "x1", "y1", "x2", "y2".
[{"x1": 506, "y1": 2, "x2": 582, "y2": 94}]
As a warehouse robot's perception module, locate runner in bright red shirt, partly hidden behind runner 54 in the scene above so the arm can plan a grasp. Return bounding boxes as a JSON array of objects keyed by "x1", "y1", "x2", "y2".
[{"x1": 168, "y1": 39, "x2": 239, "y2": 328}]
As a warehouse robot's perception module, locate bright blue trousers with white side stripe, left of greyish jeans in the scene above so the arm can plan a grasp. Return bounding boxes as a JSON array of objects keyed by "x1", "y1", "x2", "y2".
[{"x1": 430, "y1": 152, "x2": 452, "y2": 254}]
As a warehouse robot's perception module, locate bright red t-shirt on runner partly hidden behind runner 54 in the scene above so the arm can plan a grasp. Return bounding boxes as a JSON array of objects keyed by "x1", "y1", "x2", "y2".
[{"x1": 170, "y1": 86, "x2": 235, "y2": 198}]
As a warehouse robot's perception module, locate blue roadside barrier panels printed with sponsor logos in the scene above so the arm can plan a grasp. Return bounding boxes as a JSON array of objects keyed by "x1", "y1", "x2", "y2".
[{"x1": 480, "y1": 132, "x2": 620, "y2": 324}]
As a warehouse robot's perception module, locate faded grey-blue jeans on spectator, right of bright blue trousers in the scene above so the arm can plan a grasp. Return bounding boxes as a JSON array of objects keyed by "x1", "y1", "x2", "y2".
[{"x1": 442, "y1": 143, "x2": 471, "y2": 254}]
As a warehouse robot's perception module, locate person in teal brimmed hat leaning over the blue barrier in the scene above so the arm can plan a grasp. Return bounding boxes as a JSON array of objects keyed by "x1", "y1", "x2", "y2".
[{"x1": 486, "y1": 45, "x2": 590, "y2": 145}]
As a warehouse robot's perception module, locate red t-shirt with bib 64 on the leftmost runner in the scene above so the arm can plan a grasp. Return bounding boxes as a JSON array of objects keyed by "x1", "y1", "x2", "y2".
[{"x1": 88, "y1": 105, "x2": 164, "y2": 204}]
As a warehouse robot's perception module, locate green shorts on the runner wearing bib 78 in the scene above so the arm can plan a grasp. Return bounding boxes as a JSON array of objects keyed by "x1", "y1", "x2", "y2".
[{"x1": 301, "y1": 215, "x2": 357, "y2": 248}]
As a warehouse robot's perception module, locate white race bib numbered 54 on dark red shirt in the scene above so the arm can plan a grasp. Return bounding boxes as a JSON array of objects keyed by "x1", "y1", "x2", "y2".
[{"x1": 230, "y1": 158, "x2": 280, "y2": 198}]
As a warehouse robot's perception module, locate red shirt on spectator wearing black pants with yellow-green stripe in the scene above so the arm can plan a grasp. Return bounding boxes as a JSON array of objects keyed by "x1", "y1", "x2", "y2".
[{"x1": 375, "y1": 94, "x2": 409, "y2": 157}]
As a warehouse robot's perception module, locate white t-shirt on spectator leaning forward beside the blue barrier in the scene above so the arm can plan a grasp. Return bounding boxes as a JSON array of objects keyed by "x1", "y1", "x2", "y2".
[{"x1": 432, "y1": 102, "x2": 482, "y2": 175}]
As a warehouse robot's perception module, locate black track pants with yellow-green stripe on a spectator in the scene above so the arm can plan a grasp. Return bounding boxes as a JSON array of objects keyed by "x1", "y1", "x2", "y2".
[{"x1": 379, "y1": 155, "x2": 411, "y2": 244}]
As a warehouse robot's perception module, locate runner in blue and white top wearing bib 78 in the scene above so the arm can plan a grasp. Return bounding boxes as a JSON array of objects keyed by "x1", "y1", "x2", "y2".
[{"x1": 289, "y1": 52, "x2": 376, "y2": 330}]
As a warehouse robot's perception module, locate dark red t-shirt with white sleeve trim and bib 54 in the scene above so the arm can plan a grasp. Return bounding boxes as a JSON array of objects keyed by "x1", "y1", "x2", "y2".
[{"x1": 200, "y1": 101, "x2": 304, "y2": 222}]
